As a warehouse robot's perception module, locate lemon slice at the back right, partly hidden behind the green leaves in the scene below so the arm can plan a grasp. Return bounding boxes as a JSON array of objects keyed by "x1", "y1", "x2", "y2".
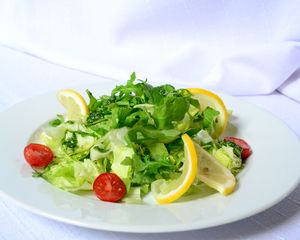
[{"x1": 188, "y1": 88, "x2": 228, "y2": 138}]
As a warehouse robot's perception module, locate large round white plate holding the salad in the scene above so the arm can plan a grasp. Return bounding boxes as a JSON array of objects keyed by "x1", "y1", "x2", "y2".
[{"x1": 0, "y1": 82, "x2": 300, "y2": 232}]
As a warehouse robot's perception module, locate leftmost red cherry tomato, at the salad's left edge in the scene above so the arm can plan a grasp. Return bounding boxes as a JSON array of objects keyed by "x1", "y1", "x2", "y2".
[{"x1": 24, "y1": 143, "x2": 54, "y2": 167}]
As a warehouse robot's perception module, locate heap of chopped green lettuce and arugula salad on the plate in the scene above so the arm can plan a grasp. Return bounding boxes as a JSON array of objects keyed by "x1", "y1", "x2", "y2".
[{"x1": 24, "y1": 73, "x2": 251, "y2": 201}]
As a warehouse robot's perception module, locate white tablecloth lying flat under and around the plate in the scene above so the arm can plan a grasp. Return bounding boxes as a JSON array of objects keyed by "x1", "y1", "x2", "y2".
[{"x1": 0, "y1": 47, "x2": 300, "y2": 240}]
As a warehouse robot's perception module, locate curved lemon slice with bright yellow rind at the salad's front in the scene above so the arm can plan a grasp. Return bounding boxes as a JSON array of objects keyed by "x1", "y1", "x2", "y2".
[{"x1": 151, "y1": 134, "x2": 197, "y2": 204}]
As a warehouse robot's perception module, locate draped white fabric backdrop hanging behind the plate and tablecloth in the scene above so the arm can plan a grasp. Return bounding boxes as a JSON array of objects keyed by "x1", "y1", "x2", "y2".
[{"x1": 0, "y1": 0, "x2": 300, "y2": 102}]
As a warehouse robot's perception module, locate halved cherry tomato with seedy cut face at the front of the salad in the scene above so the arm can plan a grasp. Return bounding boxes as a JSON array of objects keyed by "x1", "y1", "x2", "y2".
[{"x1": 93, "y1": 173, "x2": 126, "y2": 202}]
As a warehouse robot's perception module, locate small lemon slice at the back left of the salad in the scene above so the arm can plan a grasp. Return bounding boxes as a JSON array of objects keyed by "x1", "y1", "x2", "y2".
[{"x1": 57, "y1": 89, "x2": 89, "y2": 120}]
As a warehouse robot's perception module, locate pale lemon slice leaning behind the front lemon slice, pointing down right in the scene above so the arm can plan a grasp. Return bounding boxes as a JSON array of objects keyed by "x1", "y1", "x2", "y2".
[{"x1": 194, "y1": 143, "x2": 236, "y2": 195}]
